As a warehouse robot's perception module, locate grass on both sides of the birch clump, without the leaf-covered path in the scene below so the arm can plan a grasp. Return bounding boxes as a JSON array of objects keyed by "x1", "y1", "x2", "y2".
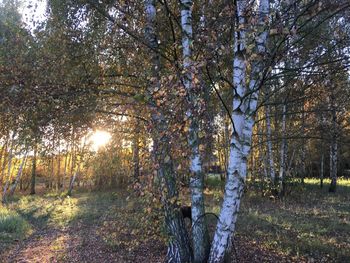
[{"x1": 0, "y1": 180, "x2": 350, "y2": 262}]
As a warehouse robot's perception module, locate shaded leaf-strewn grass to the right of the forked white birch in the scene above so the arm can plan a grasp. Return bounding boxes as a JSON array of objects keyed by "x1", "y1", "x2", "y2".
[{"x1": 207, "y1": 179, "x2": 350, "y2": 262}]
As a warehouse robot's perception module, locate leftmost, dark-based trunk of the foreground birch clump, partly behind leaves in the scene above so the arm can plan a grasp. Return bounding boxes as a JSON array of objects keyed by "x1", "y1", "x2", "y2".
[{"x1": 144, "y1": 0, "x2": 192, "y2": 263}]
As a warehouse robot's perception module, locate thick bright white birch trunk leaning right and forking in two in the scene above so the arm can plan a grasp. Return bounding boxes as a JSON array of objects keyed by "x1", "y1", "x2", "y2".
[{"x1": 209, "y1": 0, "x2": 269, "y2": 263}]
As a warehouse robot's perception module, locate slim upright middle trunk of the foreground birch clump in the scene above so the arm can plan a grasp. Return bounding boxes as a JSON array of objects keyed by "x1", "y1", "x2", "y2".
[{"x1": 181, "y1": 0, "x2": 209, "y2": 262}]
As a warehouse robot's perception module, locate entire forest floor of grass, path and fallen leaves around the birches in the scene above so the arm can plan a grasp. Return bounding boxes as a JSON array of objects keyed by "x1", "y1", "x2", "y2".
[{"x1": 0, "y1": 180, "x2": 350, "y2": 263}]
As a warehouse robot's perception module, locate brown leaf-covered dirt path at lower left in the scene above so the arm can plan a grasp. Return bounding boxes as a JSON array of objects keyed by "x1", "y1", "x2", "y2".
[{"x1": 0, "y1": 225, "x2": 164, "y2": 263}]
